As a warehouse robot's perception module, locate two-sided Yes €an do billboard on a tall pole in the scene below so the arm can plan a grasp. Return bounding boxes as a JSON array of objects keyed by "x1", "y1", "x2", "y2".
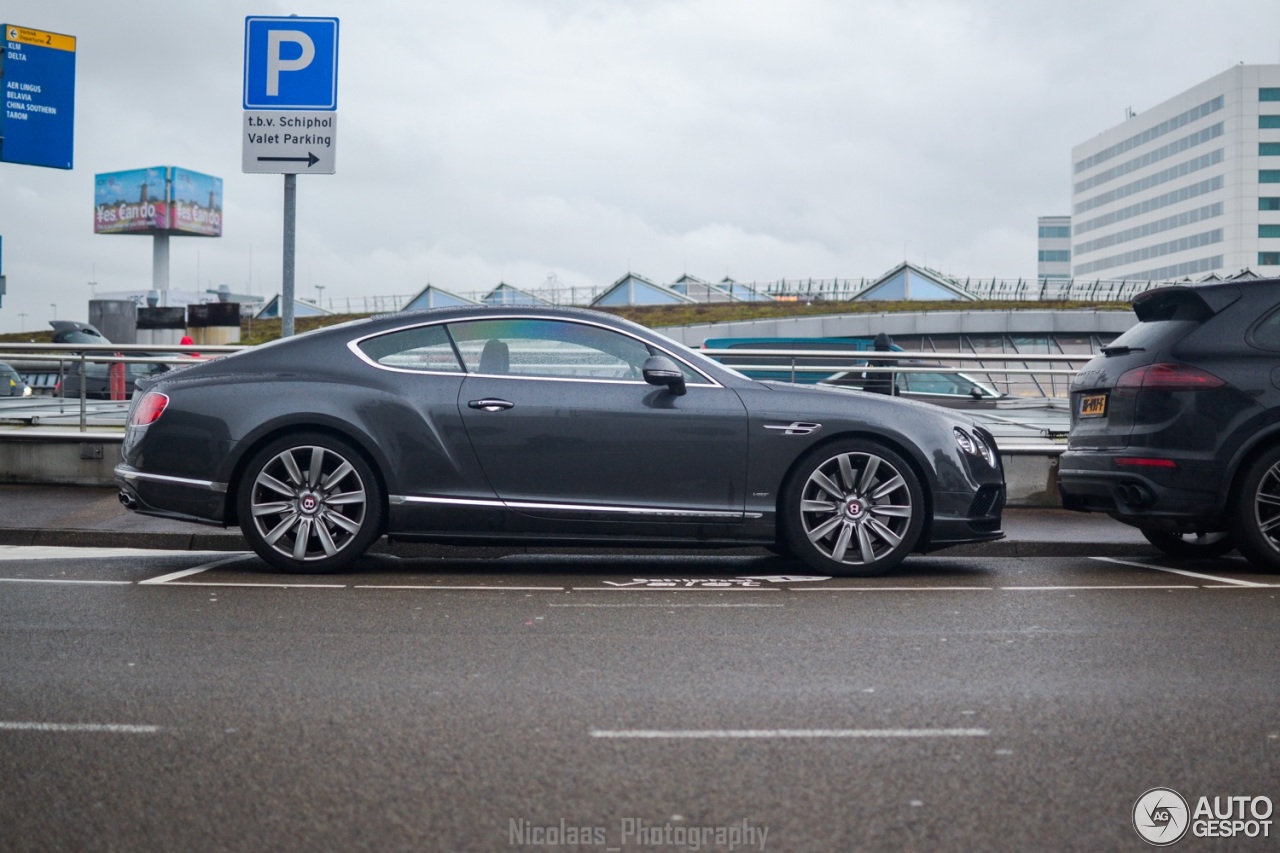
[{"x1": 93, "y1": 167, "x2": 223, "y2": 237}]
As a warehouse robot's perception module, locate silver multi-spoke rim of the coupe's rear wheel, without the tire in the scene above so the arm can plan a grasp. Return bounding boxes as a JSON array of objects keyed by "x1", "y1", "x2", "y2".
[{"x1": 250, "y1": 444, "x2": 369, "y2": 562}]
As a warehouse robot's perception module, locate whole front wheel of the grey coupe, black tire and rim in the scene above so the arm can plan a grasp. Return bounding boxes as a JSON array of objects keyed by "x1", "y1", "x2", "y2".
[{"x1": 781, "y1": 439, "x2": 925, "y2": 578}]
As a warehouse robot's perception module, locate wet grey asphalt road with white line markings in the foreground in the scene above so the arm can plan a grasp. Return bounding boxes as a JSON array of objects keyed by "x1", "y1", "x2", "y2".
[{"x1": 0, "y1": 547, "x2": 1280, "y2": 852}]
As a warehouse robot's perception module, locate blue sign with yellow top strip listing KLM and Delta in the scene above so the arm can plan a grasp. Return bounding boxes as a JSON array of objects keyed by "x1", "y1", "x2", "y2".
[{"x1": 0, "y1": 23, "x2": 76, "y2": 169}]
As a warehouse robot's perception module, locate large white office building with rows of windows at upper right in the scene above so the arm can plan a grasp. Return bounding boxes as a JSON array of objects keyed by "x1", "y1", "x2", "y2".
[{"x1": 1070, "y1": 64, "x2": 1280, "y2": 280}]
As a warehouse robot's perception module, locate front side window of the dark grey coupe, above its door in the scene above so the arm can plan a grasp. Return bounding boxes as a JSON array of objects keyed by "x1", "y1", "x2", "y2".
[{"x1": 449, "y1": 318, "x2": 691, "y2": 382}]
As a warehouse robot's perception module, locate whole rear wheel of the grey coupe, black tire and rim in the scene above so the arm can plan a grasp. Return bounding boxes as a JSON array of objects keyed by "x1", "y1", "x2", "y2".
[{"x1": 237, "y1": 433, "x2": 383, "y2": 574}]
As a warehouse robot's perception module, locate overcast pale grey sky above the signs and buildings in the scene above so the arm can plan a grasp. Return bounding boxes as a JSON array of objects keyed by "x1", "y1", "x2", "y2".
[{"x1": 0, "y1": 0, "x2": 1280, "y2": 332}]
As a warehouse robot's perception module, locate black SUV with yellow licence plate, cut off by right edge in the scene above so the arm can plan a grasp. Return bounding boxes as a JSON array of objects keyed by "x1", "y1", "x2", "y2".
[{"x1": 1059, "y1": 279, "x2": 1280, "y2": 563}]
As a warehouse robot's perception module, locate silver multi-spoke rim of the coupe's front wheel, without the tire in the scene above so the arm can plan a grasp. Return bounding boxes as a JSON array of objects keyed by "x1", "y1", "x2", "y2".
[{"x1": 800, "y1": 452, "x2": 915, "y2": 566}]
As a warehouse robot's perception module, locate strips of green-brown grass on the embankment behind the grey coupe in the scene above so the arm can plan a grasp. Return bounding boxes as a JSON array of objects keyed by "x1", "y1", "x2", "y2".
[{"x1": 0, "y1": 301, "x2": 1129, "y2": 346}]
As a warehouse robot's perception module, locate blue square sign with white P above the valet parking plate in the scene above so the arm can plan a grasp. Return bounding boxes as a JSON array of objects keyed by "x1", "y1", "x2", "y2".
[{"x1": 244, "y1": 15, "x2": 338, "y2": 110}]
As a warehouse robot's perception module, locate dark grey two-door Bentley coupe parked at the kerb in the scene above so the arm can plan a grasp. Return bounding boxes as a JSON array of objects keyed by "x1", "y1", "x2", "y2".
[{"x1": 115, "y1": 307, "x2": 1005, "y2": 575}]
